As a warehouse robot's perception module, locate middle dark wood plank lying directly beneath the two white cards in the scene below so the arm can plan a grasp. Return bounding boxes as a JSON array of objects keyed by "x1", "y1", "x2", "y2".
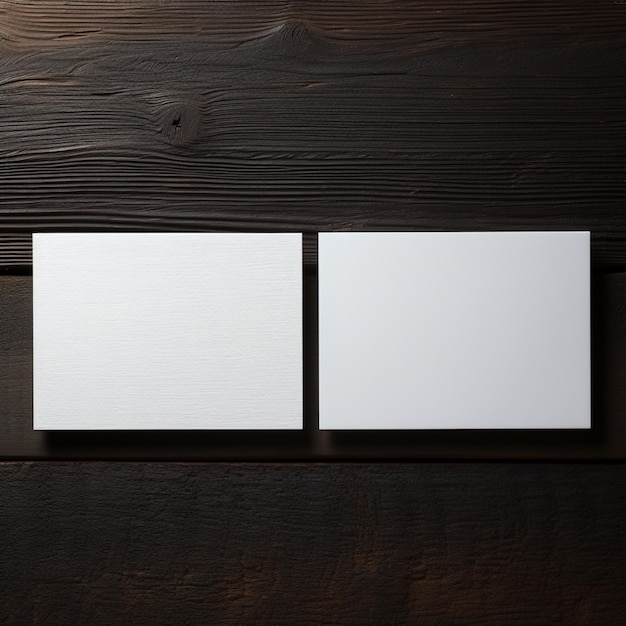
[{"x1": 0, "y1": 269, "x2": 626, "y2": 461}]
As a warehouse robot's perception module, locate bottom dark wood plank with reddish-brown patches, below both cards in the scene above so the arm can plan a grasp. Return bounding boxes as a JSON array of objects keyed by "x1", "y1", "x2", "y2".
[{"x1": 0, "y1": 463, "x2": 626, "y2": 626}]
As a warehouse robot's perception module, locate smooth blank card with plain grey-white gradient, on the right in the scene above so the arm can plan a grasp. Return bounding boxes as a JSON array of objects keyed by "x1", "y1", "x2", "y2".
[{"x1": 319, "y1": 232, "x2": 591, "y2": 429}]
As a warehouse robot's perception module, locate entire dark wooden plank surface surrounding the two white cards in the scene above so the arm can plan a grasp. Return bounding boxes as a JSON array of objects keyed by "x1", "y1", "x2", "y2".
[{"x1": 0, "y1": 0, "x2": 626, "y2": 625}]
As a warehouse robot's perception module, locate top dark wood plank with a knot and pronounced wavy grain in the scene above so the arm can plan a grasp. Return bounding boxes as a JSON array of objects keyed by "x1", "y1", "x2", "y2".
[{"x1": 0, "y1": 0, "x2": 626, "y2": 271}]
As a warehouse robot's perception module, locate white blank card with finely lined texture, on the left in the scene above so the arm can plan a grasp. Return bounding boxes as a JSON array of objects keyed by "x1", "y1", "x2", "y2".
[{"x1": 33, "y1": 233, "x2": 302, "y2": 430}]
